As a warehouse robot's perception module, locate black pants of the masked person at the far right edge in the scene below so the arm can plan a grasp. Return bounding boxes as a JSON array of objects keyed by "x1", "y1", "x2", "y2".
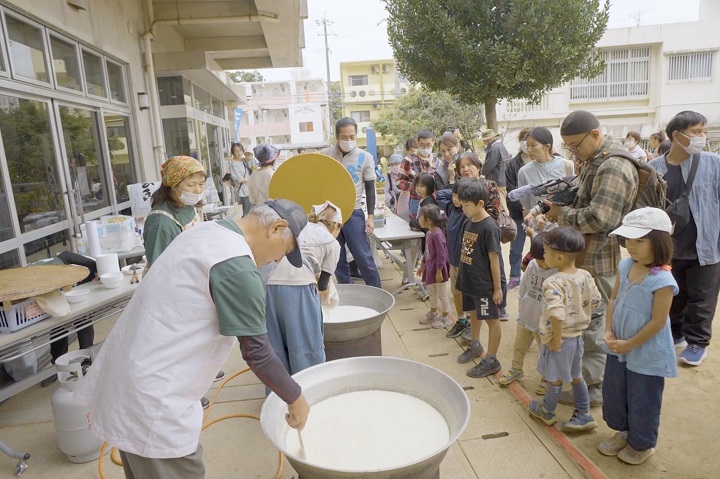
[{"x1": 670, "y1": 259, "x2": 720, "y2": 347}]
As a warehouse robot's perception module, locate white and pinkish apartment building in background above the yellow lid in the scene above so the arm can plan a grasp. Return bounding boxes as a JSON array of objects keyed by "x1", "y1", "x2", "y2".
[{"x1": 235, "y1": 74, "x2": 329, "y2": 160}]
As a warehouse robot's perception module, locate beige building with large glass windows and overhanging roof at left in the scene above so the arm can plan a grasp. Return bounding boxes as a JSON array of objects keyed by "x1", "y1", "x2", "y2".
[{"x1": 0, "y1": 0, "x2": 307, "y2": 268}]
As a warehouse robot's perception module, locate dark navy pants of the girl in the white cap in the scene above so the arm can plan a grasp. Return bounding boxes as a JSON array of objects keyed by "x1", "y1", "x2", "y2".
[{"x1": 603, "y1": 354, "x2": 665, "y2": 451}]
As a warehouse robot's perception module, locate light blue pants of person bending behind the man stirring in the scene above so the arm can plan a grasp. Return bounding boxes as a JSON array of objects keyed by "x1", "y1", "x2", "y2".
[{"x1": 265, "y1": 284, "x2": 325, "y2": 374}]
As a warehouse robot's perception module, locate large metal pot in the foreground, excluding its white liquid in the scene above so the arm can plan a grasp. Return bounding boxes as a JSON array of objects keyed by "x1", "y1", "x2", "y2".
[{"x1": 260, "y1": 356, "x2": 470, "y2": 479}]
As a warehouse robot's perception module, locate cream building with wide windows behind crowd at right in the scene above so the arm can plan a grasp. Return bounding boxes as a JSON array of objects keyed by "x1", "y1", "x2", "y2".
[{"x1": 497, "y1": 0, "x2": 720, "y2": 155}]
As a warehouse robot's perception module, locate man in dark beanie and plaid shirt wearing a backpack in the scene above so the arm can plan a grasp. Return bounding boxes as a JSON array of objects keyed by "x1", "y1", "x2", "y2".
[{"x1": 546, "y1": 110, "x2": 639, "y2": 406}]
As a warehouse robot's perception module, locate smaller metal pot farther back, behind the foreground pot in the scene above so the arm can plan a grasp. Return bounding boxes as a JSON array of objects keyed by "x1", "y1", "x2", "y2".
[{"x1": 324, "y1": 284, "x2": 395, "y2": 343}]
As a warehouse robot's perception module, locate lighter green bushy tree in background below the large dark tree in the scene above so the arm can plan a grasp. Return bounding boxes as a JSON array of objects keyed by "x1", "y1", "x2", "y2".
[{"x1": 373, "y1": 89, "x2": 483, "y2": 147}]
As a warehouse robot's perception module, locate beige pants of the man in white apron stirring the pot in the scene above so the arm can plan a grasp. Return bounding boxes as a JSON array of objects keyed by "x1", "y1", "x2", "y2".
[{"x1": 120, "y1": 444, "x2": 205, "y2": 479}]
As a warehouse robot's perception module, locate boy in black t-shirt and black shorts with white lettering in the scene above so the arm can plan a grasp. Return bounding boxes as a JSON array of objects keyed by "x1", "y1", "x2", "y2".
[{"x1": 457, "y1": 179, "x2": 505, "y2": 378}]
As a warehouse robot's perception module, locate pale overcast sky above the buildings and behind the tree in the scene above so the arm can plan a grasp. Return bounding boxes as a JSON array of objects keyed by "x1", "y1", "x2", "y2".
[{"x1": 260, "y1": 0, "x2": 700, "y2": 81}]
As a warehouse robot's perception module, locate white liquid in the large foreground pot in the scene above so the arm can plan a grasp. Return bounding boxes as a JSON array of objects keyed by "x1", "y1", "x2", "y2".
[{"x1": 285, "y1": 391, "x2": 450, "y2": 472}]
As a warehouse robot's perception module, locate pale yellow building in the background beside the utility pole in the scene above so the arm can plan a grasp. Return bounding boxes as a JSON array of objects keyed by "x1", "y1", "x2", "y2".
[{"x1": 340, "y1": 58, "x2": 410, "y2": 156}]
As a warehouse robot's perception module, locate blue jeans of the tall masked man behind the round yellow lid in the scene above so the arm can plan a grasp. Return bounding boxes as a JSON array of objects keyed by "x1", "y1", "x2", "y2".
[{"x1": 335, "y1": 209, "x2": 382, "y2": 288}]
